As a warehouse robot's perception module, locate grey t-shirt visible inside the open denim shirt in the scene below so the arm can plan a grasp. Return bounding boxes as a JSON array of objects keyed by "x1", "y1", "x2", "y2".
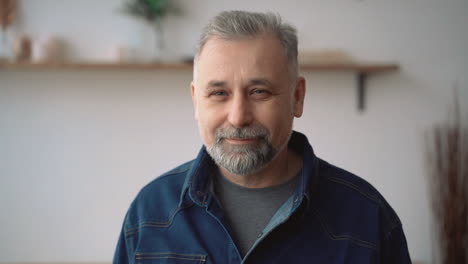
[{"x1": 213, "y1": 172, "x2": 300, "y2": 256}]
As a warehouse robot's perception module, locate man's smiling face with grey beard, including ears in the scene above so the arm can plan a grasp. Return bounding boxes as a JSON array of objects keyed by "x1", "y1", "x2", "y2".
[{"x1": 192, "y1": 34, "x2": 305, "y2": 175}]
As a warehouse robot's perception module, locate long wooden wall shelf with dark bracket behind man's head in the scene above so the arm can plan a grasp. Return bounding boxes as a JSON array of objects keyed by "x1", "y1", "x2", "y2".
[{"x1": 0, "y1": 62, "x2": 399, "y2": 111}]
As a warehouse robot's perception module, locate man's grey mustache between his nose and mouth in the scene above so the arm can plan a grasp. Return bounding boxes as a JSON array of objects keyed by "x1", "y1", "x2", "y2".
[{"x1": 216, "y1": 125, "x2": 270, "y2": 142}]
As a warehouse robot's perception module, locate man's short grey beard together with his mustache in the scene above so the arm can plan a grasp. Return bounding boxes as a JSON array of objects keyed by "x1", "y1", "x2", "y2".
[{"x1": 207, "y1": 126, "x2": 277, "y2": 176}]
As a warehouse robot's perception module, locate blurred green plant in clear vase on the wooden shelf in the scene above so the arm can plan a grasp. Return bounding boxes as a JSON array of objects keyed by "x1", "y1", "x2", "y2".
[{"x1": 121, "y1": 0, "x2": 180, "y2": 62}]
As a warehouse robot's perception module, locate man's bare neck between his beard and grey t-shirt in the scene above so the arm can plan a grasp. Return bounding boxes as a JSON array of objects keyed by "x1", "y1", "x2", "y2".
[{"x1": 220, "y1": 147, "x2": 302, "y2": 188}]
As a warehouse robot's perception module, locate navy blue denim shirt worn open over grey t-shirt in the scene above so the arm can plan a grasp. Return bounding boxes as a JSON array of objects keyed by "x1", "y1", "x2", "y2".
[{"x1": 114, "y1": 132, "x2": 411, "y2": 264}]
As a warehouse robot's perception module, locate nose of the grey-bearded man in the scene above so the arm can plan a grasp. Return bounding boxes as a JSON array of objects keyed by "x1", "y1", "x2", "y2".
[{"x1": 228, "y1": 95, "x2": 253, "y2": 127}]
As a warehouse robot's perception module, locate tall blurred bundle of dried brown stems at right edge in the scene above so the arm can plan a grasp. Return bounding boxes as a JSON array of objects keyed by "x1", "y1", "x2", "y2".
[{"x1": 426, "y1": 96, "x2": 468, "y2": 264}]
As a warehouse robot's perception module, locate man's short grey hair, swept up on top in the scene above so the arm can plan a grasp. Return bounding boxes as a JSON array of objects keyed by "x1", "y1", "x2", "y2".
[{"x1": 193, "y1": 10, "x2": 299, "y2": 81}]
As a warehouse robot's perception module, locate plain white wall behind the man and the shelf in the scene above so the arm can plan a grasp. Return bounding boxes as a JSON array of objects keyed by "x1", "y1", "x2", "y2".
[{"x1": 0, "y1": 0, "x2": 468, "y2": 263}]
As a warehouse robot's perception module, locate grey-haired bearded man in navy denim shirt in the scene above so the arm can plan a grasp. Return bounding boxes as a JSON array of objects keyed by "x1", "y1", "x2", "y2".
[{"x1": 114, "y1": 11, "x2": 411, "y2": 264}]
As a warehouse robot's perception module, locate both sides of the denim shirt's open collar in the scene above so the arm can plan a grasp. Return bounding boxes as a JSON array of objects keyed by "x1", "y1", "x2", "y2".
[{"x1": 180, "y1": 131, "x2": 318, "y2": 206}]
